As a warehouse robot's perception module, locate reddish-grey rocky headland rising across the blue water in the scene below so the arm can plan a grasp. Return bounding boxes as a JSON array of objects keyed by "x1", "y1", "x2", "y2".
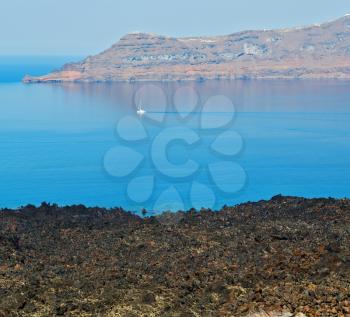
[{"x1": 24, "y1": 15, "x2": 350, "y2": 82}]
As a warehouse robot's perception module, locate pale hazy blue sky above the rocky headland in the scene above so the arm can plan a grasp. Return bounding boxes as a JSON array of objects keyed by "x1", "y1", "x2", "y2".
[{"x1": 0, "y1": 0, "x2": 350, "y2": 55}]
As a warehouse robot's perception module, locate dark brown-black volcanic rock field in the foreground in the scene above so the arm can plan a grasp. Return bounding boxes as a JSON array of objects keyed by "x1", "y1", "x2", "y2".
[{"x1": 0, "y1": 196, "x2": 350, "y2": 317}]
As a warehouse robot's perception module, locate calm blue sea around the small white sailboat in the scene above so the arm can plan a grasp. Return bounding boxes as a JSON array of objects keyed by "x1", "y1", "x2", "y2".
[{"x1": 0, "y1": 58, "x2": 350, "y2": 211}]
